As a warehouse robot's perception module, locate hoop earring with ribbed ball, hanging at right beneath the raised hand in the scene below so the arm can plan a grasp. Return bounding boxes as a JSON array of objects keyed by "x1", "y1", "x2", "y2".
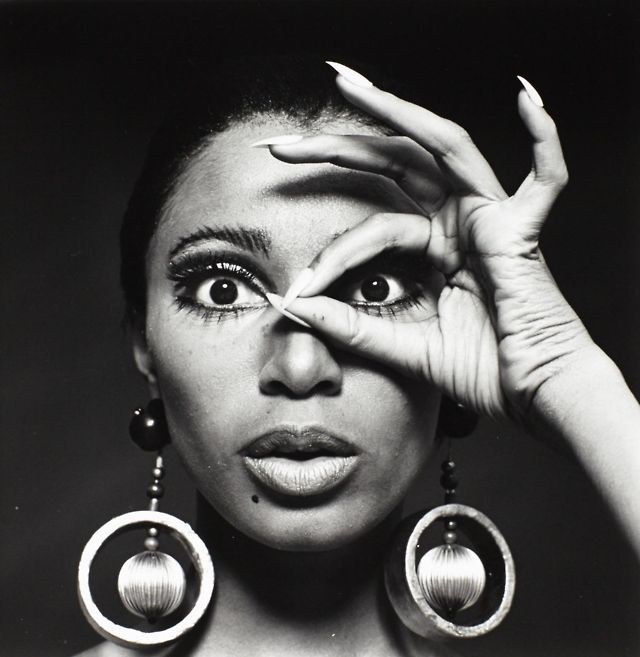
[{"x1": 385, "y1": 402, "x2": 515, "y2": 638}]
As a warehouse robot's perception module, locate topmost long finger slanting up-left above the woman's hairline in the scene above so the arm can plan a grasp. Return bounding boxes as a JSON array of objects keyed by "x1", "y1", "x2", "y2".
[{"x1": 336, "y1": 75, "x2": 506, "y2": 200}]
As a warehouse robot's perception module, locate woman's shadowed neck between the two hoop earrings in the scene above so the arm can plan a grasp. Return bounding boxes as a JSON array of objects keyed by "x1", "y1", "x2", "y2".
[{"x1": 180, "y1": 498, "x2": 412, "y2": 656}]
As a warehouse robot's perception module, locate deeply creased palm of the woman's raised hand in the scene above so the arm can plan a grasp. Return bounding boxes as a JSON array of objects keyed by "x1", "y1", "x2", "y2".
[{"x1": 416, "y1": 184, "x2": 586, "y2": 416}]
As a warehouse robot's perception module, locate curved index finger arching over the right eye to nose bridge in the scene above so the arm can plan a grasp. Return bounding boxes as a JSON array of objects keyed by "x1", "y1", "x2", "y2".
[{"x1": 285, "y1": 213, "x2": 460, "y2": 298}]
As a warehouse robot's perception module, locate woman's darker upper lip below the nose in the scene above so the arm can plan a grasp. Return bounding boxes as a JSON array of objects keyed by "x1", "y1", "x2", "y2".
[{"x1": 243, "y1": 426, "x2": 357, "y2": 458}]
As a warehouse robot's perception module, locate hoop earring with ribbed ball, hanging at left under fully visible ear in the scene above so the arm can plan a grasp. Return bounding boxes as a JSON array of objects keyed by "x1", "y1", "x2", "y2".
[{"x1": 78, "y1": 399, "x2": 215, "y2": 648}]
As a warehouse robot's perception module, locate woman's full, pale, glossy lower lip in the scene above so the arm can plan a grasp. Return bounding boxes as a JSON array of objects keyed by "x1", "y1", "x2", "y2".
[{"x1": 244, "y1": 456, "x2": 357, "y2": 497}]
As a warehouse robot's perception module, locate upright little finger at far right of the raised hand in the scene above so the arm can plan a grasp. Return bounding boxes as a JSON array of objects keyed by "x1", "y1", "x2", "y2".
[{"x1": 514, "y1": 90, "x2": 569, "y2": 227}]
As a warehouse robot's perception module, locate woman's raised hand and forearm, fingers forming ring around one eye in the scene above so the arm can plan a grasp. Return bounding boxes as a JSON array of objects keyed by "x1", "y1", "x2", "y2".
[{"x1": 271, "y1": 70, "x2": 640, "y2": 557}]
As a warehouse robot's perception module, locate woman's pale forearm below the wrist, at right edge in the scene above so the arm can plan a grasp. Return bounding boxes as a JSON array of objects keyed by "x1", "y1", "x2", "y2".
[{"x1": 532, "y1": 345, "x2": 640, "y2": 557}]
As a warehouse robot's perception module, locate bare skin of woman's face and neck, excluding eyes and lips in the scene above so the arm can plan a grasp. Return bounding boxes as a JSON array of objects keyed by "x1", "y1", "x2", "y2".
[{"x1": 80, "y1": 119, "x2": 447, "y2": 657}]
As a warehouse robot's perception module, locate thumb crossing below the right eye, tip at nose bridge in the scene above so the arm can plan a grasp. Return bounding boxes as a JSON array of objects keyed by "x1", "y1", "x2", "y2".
[{"x1": 289, "y1": 297, "x2": 430, "y2": 377}]
